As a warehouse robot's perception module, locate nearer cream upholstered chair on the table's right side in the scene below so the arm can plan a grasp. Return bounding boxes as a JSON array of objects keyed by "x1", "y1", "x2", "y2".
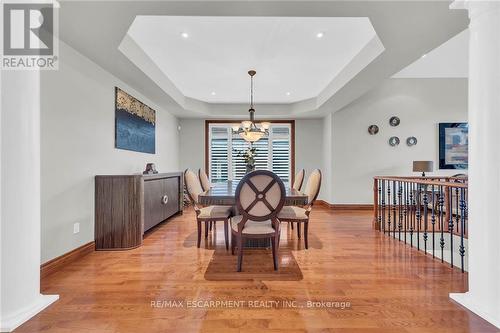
[{"x1": 278, "y1": 169, "x2": 321, "y2": 249}]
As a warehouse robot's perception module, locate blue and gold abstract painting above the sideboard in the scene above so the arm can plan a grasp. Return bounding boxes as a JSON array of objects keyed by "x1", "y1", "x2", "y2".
[{"x1": 115, "y1": 87, "x2": 156, "y2": 154}]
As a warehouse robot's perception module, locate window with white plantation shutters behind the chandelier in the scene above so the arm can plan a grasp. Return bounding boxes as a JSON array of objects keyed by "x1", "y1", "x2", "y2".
[{"x1": 206, "y1": 121, "x2": 294, "y2": 183}]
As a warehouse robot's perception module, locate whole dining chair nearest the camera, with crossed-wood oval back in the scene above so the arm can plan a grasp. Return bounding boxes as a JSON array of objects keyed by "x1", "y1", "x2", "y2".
[{"x1": 231, "y1": 170, "x2": 285, "y2": 272}]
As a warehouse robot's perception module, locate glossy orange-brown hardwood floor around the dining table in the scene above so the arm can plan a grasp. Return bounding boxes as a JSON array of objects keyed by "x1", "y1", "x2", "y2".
[{"x1": 16, "y1": 207, "x2": 498, "y2": 333}]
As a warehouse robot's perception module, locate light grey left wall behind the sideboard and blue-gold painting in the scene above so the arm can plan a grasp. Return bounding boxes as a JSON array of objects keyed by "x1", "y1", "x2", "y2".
[{"x1": 41, "y1": 42, "x2": 179, "y2": 262}]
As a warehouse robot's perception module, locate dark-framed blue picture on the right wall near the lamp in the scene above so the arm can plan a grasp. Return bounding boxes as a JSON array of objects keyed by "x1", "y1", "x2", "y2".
[{"x1": 439, "y1": 123, "x2": 469, "y2": 170}]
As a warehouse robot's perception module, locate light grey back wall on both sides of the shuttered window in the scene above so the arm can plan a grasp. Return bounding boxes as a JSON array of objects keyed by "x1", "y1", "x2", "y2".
[{"x1": 179, "y1": 119, "x2": 323, "y2": 182}]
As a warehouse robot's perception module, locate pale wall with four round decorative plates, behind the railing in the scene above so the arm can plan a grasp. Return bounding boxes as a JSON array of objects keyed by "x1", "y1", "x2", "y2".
[{"x1": 325, "y1": 79, "x2": 467, "y2": 204}]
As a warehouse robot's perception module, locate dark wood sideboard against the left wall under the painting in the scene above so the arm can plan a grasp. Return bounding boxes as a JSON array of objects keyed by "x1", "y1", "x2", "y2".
[{"x1": 94, "y1": 172, "x2": 184, "y2": 250}]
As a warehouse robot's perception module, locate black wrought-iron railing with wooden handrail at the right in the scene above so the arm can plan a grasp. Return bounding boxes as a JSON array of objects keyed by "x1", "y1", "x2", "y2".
[{"x1": 373, "y1": 176, "x2": 468, "y2": 272}]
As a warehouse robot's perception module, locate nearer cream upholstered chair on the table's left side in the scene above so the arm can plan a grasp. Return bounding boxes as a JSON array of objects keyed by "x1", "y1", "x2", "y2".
[{"x1": 184, "y1": 169, "x2": 231, "y2": 250}]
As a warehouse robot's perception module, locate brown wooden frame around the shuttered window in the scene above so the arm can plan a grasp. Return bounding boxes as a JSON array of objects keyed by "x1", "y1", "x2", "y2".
[{"x1": 205, "y1": 119, "x2": 295, "y2": 184}]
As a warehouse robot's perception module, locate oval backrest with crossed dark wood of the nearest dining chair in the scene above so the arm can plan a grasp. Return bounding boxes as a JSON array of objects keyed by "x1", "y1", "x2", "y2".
[{"x1": 236, "y1": 170, "x2": 286, "y2": 221}]
